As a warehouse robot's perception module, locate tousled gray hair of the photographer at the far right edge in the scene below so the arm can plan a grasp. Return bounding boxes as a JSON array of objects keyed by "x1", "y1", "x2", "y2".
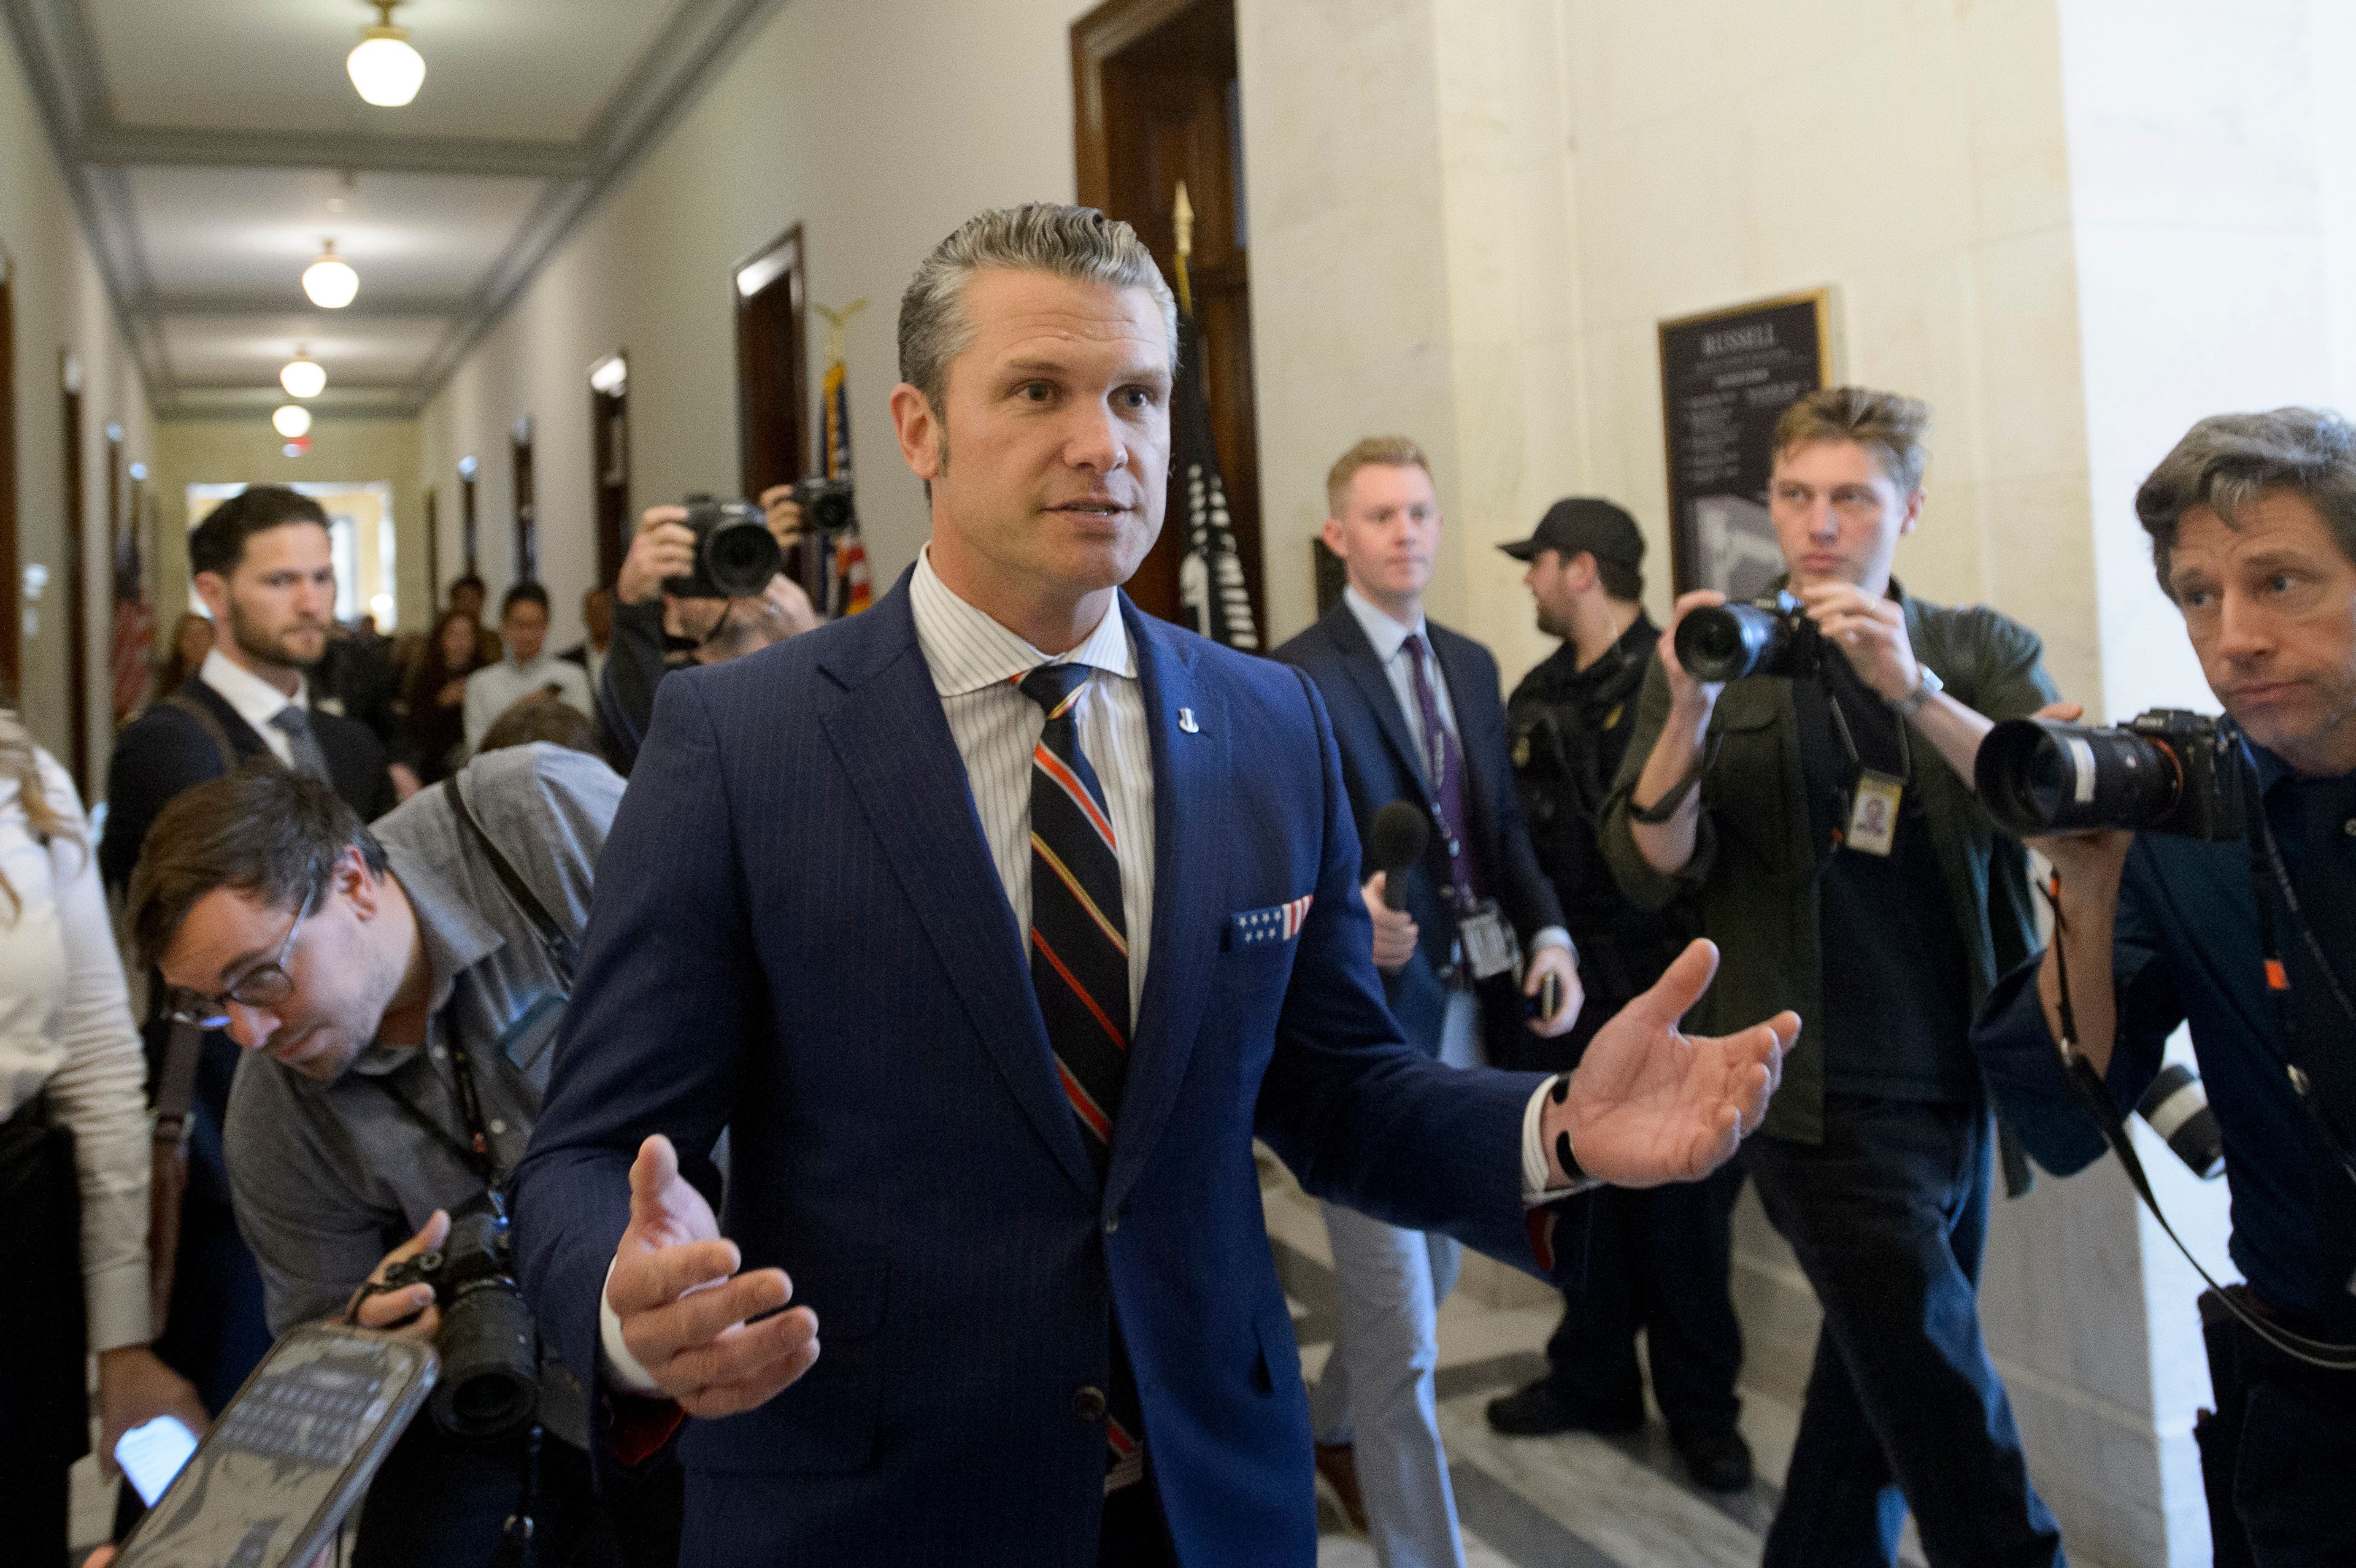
[{"x1": 2135, "y1": 407, "x2": 2356, "y2": 598}]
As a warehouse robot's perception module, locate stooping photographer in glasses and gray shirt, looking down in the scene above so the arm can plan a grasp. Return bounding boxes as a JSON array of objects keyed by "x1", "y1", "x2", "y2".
[{"x1": 129, "y1": 747, "x2": 679, "y2": 1568}]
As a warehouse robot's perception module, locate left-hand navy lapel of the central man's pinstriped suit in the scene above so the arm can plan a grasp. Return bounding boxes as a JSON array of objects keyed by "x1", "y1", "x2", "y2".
[{"x1": 820, "y1": 577, "x2": 1098, "y2": 1196}]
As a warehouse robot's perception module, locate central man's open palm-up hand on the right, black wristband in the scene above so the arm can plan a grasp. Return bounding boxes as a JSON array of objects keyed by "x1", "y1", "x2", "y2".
[{"x1": 1543, "y1": 942, "x2": 1800, "y2": 1186}]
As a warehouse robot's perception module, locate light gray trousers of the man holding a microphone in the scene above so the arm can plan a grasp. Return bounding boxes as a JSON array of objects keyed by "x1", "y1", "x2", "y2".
[{"x1": 1310, "y1": 994, "x2": 1482, "y2": 1568}]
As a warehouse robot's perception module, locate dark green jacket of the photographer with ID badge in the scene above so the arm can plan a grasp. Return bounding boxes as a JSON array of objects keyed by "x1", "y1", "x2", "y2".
[{"x1": 1602, "y1": 584, "x2": 2057, "y2": 1189}]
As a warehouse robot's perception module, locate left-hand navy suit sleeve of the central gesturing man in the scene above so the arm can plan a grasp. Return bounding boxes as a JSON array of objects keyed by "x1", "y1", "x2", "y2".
[{"x1": 516, "y1": 664, "x2": 763, "y2": 1450}]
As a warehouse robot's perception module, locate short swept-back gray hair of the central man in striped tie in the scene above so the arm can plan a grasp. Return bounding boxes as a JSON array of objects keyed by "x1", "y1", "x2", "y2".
[{"x1": 900, "y1": 202, "x2": 1178, "y2": 412}]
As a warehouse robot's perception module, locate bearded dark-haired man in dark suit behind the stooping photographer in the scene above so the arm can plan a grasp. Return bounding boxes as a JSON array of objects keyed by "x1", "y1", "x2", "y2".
[{"x1": 99, "y1": 485, "x2": 393, "y2": 1502}]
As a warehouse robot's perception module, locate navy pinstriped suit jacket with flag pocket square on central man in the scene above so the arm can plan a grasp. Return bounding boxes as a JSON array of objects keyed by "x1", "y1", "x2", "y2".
[{"x1": 516, "y1": 577, "x2": 1583, "y2": 1568}]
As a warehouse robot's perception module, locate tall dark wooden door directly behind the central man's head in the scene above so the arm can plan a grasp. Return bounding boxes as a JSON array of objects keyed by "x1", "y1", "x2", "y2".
[{"x1": 1072, "y1": 0, "x2": 1268, "y2": 626}]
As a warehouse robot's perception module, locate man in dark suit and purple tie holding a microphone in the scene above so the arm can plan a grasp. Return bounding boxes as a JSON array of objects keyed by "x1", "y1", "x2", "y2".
[{"x1": 1277, "y1": 436, "x2": 1581, "y2": 1568}]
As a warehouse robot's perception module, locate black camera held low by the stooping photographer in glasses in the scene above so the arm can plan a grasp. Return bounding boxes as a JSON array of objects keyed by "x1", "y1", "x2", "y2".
[{"x1": 384, "y1": 1194, "x2": 539, "y2": 1436}]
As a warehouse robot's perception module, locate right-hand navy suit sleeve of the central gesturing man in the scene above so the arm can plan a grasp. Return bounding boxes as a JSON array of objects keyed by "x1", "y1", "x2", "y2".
[{"x1": 1256, "y1": 675, "x2": 1583, "y2": 1271}]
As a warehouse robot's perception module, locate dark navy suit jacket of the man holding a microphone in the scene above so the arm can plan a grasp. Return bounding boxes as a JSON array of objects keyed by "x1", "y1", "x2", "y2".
[{"x1": 1277, "y1": 602, "x2": 1562, "y2": 1053}]
